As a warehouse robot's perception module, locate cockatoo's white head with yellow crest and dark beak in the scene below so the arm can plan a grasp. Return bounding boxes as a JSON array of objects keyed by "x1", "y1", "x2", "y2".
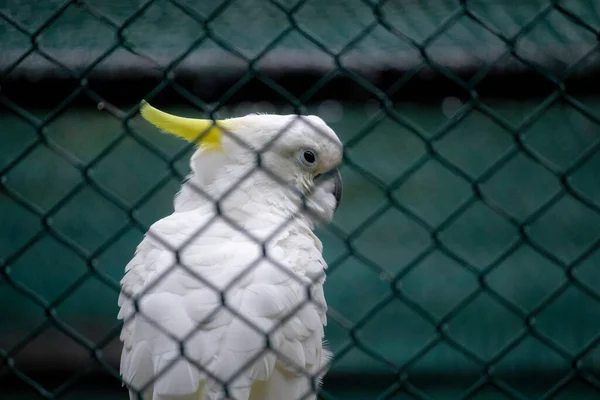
[{"x1": 141, "y1": 102, "x2": 342, "y2": 227}]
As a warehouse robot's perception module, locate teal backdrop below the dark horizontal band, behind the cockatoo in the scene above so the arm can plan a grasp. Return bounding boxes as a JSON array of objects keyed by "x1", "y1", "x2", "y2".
[{"x1": 0, "y1": 98, "x2": 600, "y2": 399}]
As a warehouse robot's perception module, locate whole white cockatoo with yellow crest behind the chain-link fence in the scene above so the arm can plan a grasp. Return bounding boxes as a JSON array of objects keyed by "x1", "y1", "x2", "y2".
[{"x1": 119, "y1": 102, "x2": 342, "y2": 400}]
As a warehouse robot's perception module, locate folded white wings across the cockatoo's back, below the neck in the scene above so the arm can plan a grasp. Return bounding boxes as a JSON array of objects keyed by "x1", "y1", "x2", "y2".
[{"x1": 119, "y1": 208, "x2": 324, "y2": 399}]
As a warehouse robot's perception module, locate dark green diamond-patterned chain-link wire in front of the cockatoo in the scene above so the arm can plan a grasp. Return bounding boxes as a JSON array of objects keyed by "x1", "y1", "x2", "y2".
[{"x1": 0, "y1": 0, "x2": 600, "y2": 399}]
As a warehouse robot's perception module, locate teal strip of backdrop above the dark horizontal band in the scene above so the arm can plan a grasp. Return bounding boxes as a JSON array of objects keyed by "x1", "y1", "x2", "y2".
[{"x1": 0, "y1": 0, "x2": 600, "y2": 75}]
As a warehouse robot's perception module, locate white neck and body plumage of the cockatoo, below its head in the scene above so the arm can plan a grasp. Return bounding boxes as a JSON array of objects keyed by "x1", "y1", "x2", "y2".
[{"x1": 119, "y1": 112, "x2": 341, "y2": 400}]
